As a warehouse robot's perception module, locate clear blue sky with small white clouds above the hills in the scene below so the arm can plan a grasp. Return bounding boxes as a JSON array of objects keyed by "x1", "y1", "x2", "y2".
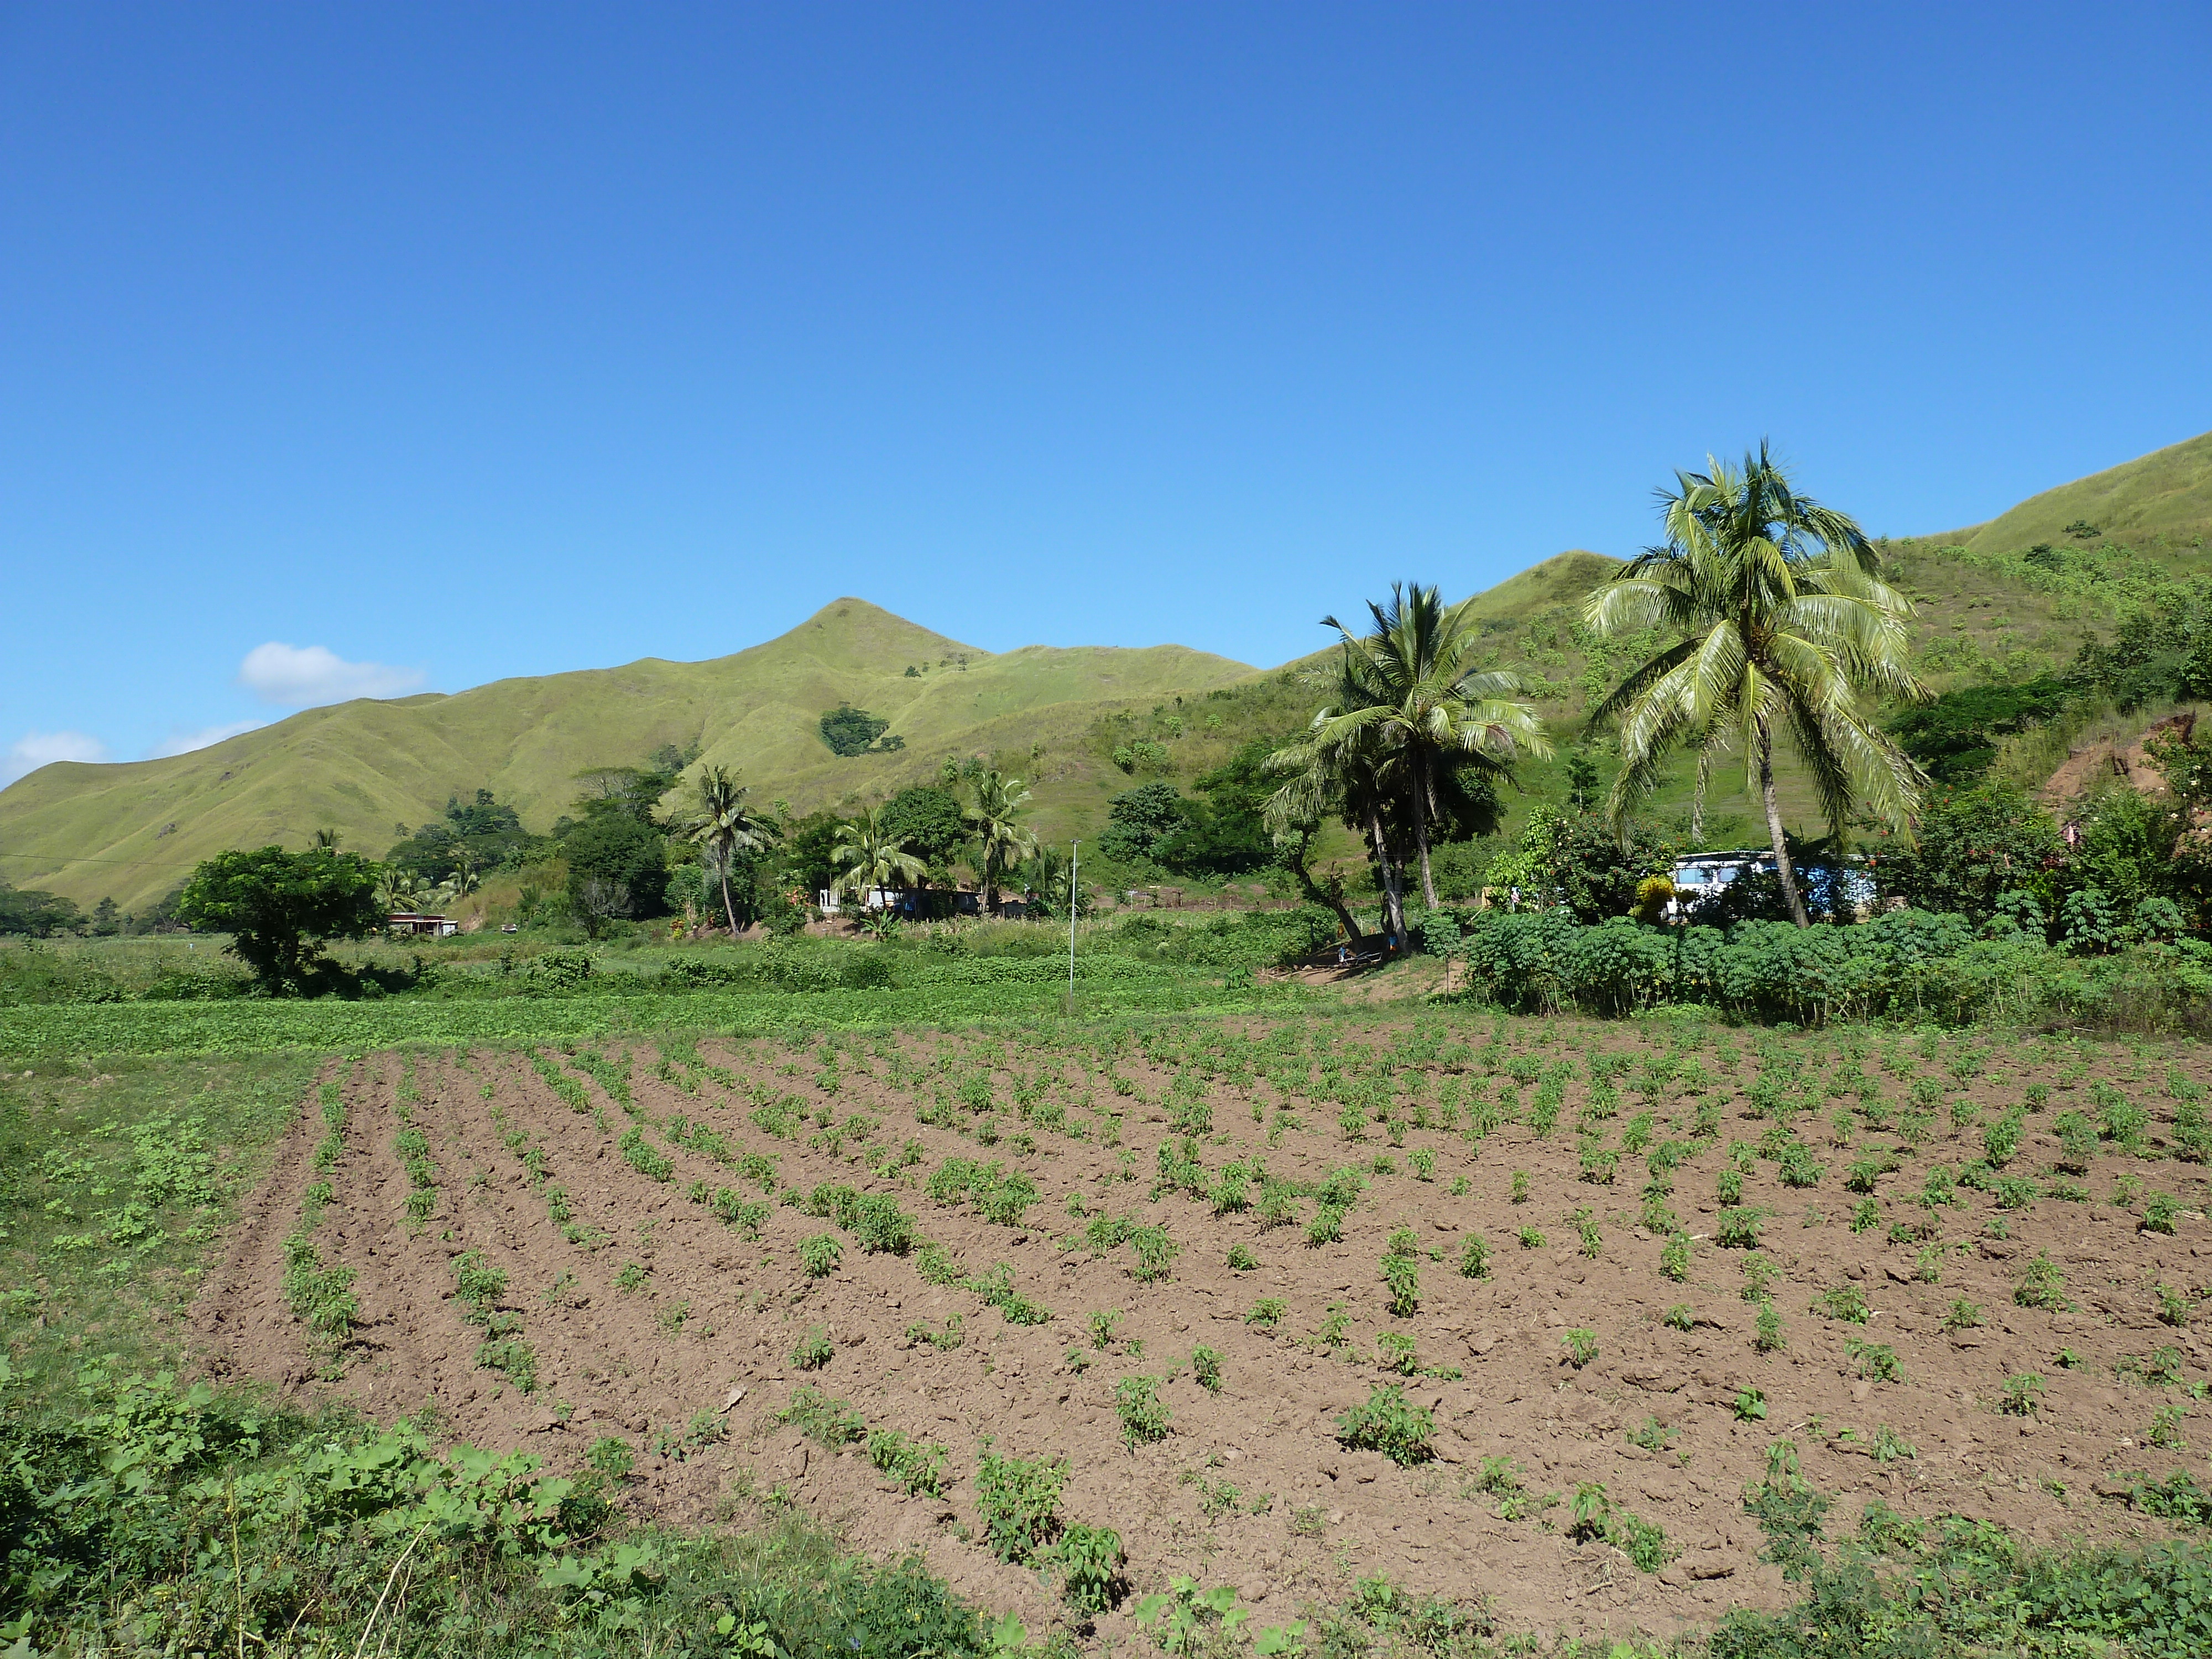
[{"x1": 0, "y1": 0, "x2": 2212, "y2": 781}]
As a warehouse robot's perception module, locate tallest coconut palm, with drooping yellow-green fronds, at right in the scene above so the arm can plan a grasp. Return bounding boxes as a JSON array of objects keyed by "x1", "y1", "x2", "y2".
[{"x1": 1584, "y1": 442, "x2": 1929, "y2": 927}]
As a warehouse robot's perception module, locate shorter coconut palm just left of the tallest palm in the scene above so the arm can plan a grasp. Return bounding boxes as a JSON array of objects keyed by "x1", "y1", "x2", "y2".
[{"x1": 1314, "y1": 582, "x2": 1551, "y2": 909}]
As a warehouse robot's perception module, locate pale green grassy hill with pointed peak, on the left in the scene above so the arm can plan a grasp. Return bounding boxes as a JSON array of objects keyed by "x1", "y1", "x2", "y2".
[{"x1": 0, "y1": 599, "x2": 1252, "y2": 907}]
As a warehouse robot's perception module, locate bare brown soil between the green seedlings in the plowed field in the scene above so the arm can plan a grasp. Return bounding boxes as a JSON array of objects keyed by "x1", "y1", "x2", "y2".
[{"x1": 199, "y1": 1011, "x2": 2212, "y2": 1632}]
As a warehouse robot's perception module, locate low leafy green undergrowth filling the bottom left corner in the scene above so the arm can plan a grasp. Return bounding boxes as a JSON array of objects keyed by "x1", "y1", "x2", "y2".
[{"x1": 0, "y1": 1360, "x2": 989, "y2": 1659}]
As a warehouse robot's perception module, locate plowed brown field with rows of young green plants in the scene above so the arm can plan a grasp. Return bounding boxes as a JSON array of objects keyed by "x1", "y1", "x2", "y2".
[{"x1": 199, "y1": 1013, "x2": 2212, "y2": 1630}]
